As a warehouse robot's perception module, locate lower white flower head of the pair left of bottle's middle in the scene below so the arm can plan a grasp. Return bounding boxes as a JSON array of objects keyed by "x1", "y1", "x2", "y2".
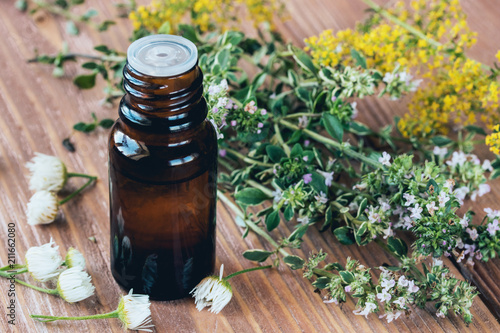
[{"x1": 26, "y1": 191, "x2": 59, "y2": 225}]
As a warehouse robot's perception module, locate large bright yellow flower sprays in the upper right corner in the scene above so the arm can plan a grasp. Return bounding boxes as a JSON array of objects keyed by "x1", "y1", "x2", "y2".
[{"x1": 305, "y1": 0, "x2": 500, "y2": 137}]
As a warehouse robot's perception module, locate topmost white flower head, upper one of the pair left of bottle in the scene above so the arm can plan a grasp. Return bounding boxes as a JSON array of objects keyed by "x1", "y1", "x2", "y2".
[{"x1": 26, "y1": 153, "x2": 67, "y2": 192}]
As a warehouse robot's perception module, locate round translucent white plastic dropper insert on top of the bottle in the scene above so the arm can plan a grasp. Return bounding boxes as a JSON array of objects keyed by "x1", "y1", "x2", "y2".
[{"x1": 127, "y1": 35, "x2": 198, "y2": 77}]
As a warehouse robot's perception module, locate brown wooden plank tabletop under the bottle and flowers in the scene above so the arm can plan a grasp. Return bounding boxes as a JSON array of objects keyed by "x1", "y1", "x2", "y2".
[{"x1": 0, "y1": 0, "x2": 500, "y2": 333}]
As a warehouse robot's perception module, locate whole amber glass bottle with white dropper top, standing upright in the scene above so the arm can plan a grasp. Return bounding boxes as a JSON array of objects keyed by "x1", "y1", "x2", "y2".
[{"x1": 109, "y1": 35, "x2": 217, "y2": 300}]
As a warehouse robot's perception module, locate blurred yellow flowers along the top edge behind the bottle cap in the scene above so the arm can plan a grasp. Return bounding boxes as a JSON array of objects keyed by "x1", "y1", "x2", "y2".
[{"x1": 129, "y1": 0, "x2": 284, "y2": 32}]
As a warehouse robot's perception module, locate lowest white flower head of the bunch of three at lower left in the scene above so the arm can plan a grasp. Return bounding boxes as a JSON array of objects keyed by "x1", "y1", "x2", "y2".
[{"x1": 57, "y1": 267, "x2": 95, "y2": 303}]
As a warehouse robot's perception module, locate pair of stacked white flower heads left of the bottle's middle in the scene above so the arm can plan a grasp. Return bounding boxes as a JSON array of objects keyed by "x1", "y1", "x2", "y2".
[{"x1": 26, "y1": 153, "x2": 67, "y2": 225}]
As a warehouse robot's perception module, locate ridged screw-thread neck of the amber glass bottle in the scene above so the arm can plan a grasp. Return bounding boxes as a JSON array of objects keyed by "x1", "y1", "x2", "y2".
[{"x1": 119, "y1": 63, "x2": 208, "y2": 133}]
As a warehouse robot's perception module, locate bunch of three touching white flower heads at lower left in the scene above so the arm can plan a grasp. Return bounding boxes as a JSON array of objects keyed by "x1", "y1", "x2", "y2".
[{"x1": 25, "y1": 239, "x2": 95, "y2": 303}]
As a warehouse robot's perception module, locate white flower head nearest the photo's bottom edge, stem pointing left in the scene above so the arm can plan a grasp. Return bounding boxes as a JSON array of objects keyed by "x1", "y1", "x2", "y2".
[{"x1": 117, "y1": 289, "x2": 154, "y2": 332}]
